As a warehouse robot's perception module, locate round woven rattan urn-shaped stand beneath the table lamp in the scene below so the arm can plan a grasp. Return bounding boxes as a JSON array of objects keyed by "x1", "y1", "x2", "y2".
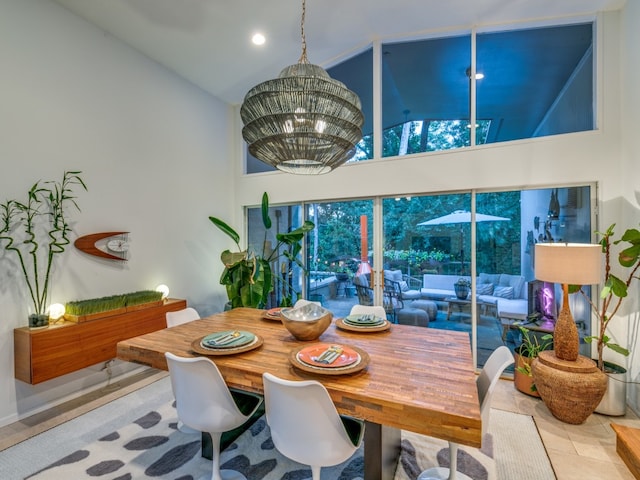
[{"x1": 531, "y1": 351, "x2": 607, "y2": 425}]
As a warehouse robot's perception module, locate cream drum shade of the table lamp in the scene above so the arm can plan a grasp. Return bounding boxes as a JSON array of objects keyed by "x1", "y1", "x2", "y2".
[{"x1": 535, "y1": 243, "x2": 602, "y2": 285}]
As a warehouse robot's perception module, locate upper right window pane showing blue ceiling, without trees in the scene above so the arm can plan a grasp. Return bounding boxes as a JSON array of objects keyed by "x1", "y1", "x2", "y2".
[{"x1": 476, "y1": 23, "x2": 594, "y2": 142}]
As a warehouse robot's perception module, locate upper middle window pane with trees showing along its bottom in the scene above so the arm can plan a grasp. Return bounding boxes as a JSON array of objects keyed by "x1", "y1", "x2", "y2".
[{"x1": 381, "y1": 35, "x2": 471, "y2": 157}]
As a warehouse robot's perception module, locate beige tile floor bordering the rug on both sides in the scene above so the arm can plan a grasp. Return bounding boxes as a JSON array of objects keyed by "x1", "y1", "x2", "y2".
[{"x1": 0, "y1": 369, "x2": 640, "y2": 480}]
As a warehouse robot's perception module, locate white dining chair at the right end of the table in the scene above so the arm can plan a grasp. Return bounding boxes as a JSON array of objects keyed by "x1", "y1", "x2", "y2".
[{"x1": 417, "y1": 345, "x2": 514, "y2": 480}]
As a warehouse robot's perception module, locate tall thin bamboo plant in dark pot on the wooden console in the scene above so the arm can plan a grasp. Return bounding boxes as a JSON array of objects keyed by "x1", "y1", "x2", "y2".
[{"x1": 0, "y1": 172, "x2": 87, "y2": 328}]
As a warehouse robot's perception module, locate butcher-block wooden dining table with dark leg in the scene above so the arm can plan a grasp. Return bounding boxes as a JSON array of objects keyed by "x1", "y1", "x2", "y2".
[{"x1": 117, "y1": 308, "x2": 481, "y2": 480}]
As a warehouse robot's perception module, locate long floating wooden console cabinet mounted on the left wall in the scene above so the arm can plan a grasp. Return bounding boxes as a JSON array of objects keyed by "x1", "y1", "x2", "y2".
[{"x1": 13, "y1": 299, "x2": 187, "y2": 385}]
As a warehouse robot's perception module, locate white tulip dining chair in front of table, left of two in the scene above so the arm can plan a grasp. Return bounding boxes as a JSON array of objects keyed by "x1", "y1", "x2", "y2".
[{"x1": 165, "y1": 352, "x2": 263, "y2": 480}]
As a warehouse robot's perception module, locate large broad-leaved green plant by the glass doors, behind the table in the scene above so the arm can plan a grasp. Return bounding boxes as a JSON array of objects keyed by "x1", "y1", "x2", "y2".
[{"x1": 209, "y1": 192, "x2": 315, "y2": 308}]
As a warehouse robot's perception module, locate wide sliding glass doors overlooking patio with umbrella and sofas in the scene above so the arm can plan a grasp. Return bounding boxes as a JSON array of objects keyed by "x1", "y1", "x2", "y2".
[{"x1": 249, "y1": 186, "x2": 595, "y2": 366}]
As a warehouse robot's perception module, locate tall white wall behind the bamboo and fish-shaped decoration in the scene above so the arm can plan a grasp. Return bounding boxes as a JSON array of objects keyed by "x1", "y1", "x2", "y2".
[{"x1": 0, "y1": 0, "x2": 233, "y2": 424}]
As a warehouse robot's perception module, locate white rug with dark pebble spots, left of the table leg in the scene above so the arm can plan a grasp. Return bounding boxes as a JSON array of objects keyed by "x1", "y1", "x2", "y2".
[{"x1": 26, "y1": 403, "x2": 363, "y2": 480}]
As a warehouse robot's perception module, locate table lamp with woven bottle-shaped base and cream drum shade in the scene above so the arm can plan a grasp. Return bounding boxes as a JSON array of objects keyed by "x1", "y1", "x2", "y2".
[{"x1": 535, "y1": 243, "x2": 602, "y2": 361}]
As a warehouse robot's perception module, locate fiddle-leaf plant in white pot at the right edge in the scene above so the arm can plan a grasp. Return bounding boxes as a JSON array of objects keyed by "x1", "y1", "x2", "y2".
[{"x1": 569, "y1": 224, "x2": 640, "y2": 415}]
